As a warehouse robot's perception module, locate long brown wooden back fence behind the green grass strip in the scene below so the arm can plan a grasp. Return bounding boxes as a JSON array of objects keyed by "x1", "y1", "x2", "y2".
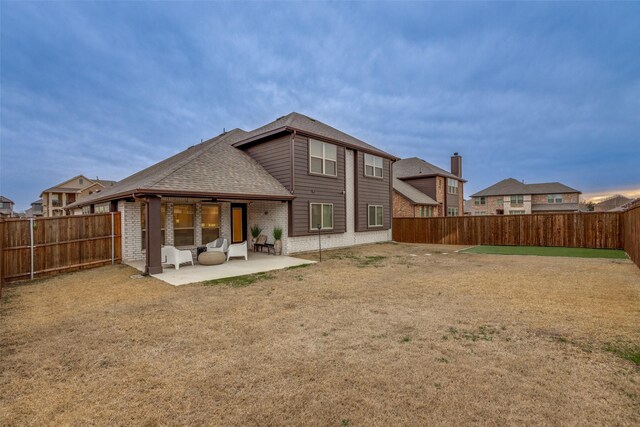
[{"x1": 393, "y1": 212, "x2": 623, "y2": 249}]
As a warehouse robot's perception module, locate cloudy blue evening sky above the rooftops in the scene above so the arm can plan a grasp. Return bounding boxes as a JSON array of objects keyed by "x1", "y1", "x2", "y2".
[{"x1": 0, "y1": 2, "x2": 640, "y2": 210}]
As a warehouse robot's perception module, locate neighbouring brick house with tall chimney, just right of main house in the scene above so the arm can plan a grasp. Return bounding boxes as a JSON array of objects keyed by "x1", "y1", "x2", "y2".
[{"x1": 393, "y1": 153, "x2": 467, "y2": 218}]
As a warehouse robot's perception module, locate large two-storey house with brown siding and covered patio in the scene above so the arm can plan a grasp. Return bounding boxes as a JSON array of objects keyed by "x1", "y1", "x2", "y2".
[{"x1": 73, "y1": 113, "x2": 396, "y2": 273}]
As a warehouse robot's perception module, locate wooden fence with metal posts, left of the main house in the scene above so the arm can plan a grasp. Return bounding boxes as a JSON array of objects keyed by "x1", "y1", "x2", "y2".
[{"x1": 0, "y1": 212, "x2": 122, "y2": 286}]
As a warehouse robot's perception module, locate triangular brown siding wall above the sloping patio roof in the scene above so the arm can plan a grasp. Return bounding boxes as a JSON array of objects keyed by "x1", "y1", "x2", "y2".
[{"x1": 246, "y1": 134, "x2": 291, "y2": 191}]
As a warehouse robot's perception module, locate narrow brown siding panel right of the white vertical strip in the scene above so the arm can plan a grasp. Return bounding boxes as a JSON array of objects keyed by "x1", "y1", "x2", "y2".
[{"x1": 355, "y1": 151, "x2": 393, "y2": 231}]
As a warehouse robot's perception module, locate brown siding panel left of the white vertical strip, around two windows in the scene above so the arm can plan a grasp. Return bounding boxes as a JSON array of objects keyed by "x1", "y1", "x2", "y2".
[{"x1": 289, "y1": 135, "x2": 347, "y2": 236}]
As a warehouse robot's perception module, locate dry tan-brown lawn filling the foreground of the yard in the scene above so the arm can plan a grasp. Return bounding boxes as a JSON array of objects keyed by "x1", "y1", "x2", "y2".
[{"x1": 0, "y1": 244, "x2": 640, "y2": 426}]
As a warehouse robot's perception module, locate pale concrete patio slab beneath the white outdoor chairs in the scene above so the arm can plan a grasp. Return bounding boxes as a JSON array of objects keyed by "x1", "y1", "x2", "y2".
[{"x1": 127, "y1": 252, "x2": 315, "y2": 286}]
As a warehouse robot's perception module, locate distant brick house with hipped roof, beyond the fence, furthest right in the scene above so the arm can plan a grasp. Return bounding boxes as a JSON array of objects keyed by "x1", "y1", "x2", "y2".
[{"x1": 471, "y1": 178, "x2": 581, "y2": 215}]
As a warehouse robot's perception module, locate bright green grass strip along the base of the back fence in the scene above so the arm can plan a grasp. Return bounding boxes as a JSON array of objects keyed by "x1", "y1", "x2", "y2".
[{"x1": 461, "y1": 245, "x2": 627, "y2": 259}]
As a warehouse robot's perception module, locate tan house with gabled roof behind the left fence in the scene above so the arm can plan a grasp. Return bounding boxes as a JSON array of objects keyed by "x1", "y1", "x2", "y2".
[{"x1": 40, "y1": 175, "x2": 116, "y2": 217}]
